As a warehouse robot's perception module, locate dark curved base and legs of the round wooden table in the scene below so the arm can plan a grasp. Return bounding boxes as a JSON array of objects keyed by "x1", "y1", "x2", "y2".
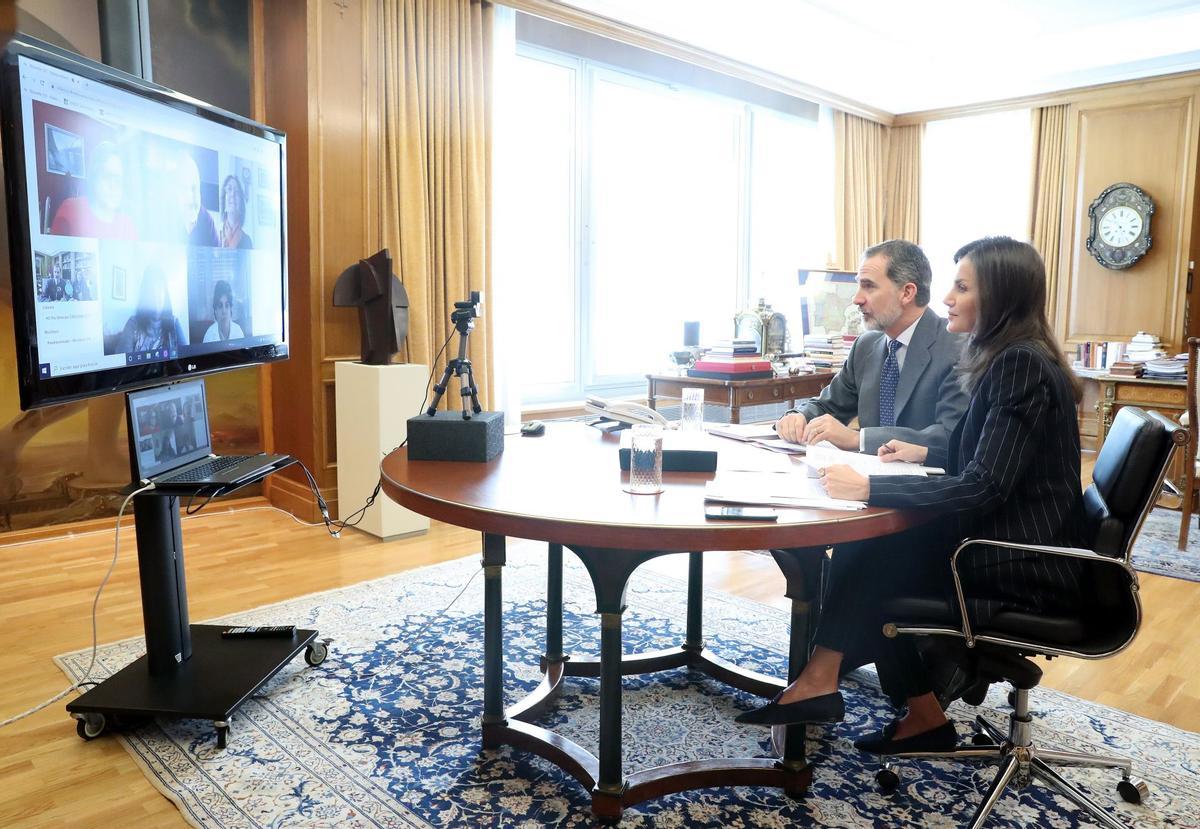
[{"x1": 482, "y1": 534, "x2": 824, "y2": 824}]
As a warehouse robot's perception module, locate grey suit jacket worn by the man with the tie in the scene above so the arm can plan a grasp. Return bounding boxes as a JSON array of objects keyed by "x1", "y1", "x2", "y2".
[{"x1": 798, "y1": 308, "x2": 967, "y2": 455}]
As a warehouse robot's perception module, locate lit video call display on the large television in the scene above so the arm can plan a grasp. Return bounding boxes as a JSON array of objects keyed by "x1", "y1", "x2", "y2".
[{"x1": 18, "y1": 55, "x2": 283, "y2": 379}]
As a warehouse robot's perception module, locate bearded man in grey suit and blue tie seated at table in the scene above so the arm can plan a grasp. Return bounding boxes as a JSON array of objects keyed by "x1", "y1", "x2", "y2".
[{"x1": 776, "y1": 239, "x2": 967, "y2": 455}]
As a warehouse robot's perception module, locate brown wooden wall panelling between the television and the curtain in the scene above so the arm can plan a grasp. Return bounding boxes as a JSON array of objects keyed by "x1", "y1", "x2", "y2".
[{"x1": 259, "y1": 0, "x2": 383, "y2": 518}]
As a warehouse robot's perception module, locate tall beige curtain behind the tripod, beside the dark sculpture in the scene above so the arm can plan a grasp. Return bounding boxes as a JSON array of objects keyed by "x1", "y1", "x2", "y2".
[{"x1": 383, "y1": 0, "x2": 493, "y2": 408}]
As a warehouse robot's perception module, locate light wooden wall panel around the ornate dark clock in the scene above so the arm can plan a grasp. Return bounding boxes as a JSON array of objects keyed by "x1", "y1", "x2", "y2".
[{"x1": 1055, "y1": 88, "x2": 1196, "y2": 348}]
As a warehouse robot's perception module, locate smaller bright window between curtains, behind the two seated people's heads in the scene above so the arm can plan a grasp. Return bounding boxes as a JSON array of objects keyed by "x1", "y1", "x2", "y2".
[{"x1": 920, "y1": 109, "x2": 1033, "y2": 317}]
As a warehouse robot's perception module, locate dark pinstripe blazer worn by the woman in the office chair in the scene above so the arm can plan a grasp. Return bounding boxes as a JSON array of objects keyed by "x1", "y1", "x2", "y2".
[{"x1": 869, "y1": 343, "x2": 1084, "y2": 618}]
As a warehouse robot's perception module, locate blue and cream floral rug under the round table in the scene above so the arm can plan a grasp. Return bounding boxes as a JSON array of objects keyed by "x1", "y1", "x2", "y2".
[{"x1": 59, "y1": 545, "x2": 1200, "y2": 829}]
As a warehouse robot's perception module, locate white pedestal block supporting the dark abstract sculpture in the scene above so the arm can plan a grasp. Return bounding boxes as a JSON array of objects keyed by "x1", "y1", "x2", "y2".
[{"x1": 334, "y1": 361, "x2": 430, "y2": 539}]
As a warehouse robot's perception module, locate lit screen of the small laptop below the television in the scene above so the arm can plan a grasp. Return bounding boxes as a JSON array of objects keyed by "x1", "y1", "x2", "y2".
[{"x1": 128, "y1": 380, "x2": 212, "y2": 480}]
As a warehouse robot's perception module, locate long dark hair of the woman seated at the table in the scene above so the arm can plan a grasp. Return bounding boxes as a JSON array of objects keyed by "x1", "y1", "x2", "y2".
[{"x1": 954, "y1": 236, "x2": 1084, "y2": 402}]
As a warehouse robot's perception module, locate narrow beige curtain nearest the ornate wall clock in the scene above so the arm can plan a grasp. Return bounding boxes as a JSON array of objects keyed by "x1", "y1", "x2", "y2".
[{"x1": 1030, "y1": 103, "x2": 1070, "y2": 311}]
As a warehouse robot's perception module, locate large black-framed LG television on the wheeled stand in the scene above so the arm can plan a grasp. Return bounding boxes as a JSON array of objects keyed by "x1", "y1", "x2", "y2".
[{"x1": 0, "y1": 36, "x2": 288, "y2": 409}]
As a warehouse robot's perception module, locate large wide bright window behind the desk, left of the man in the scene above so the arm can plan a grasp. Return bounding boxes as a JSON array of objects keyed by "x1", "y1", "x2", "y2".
[{"x1": 494, "y1": 44, "x2": 833, "y2": 404}]
